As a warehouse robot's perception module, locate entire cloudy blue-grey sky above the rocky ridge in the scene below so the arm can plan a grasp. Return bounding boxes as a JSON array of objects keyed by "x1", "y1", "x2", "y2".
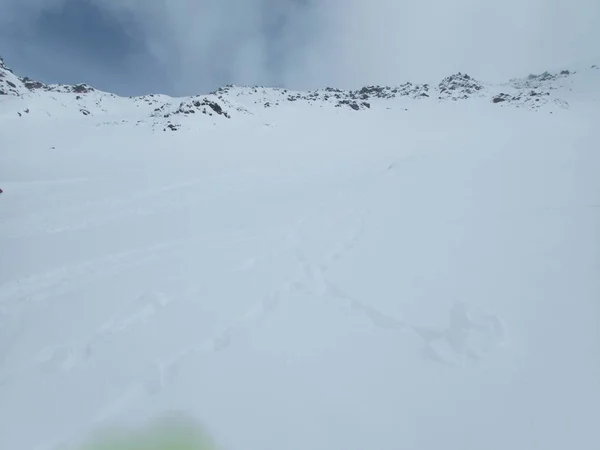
[{"x1": 0, "y1": 0, "x2": 600, "y2": 95}]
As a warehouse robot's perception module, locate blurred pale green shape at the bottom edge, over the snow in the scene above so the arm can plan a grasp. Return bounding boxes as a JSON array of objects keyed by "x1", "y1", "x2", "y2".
[{"x1": 73, "y1": 417, "x2": 219, "y2": 450}]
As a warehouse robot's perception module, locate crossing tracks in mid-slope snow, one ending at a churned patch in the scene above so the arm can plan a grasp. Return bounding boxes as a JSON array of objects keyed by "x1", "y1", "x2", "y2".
[{"x1": 72, "y1": 163, "x2": 506, "y2": 432}]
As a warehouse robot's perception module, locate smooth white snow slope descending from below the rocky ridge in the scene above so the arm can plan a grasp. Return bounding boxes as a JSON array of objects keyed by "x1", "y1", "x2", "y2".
[{"x1": 0, "y1": 59, "x2": 600, "y2": 450}]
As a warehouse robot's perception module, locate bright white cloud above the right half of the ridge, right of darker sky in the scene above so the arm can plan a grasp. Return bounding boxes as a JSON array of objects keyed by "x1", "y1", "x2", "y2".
[{"x1": 291, "y1": 0, "x2": 600, "y2": 86}]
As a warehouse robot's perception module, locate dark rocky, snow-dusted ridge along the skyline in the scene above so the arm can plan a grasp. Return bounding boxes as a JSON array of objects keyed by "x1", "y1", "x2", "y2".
[{"x1": 0, "y1": 57, "x2": 600, "y2": 131}]
